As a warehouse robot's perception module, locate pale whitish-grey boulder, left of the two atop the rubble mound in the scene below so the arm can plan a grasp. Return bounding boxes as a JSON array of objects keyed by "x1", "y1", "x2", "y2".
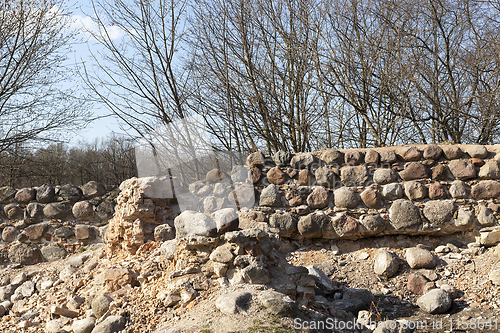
[{"x1": 174, "y1": 210, "x2": 217, "y2": 238}]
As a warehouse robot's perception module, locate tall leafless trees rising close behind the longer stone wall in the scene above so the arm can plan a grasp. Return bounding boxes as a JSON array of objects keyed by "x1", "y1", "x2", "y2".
[{"x1": 87, "y1": 0, "x2": 500, "y2": 153}]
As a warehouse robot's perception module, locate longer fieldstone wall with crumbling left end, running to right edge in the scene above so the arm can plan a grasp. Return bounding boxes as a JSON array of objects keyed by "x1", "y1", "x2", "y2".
[{"x1": 106, "y1": 145, "x2": 500, "y2": 252}]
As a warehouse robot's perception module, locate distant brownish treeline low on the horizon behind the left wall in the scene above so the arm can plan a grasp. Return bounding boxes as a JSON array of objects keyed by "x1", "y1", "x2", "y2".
[{"x1": 0, "y1": 136, "x2": 137, "y2": 188}]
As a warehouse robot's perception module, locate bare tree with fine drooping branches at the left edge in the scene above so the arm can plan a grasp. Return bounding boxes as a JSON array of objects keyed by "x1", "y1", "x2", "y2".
[{"x1": 0, "y1": 0, "x2": 88, "y2": 151}]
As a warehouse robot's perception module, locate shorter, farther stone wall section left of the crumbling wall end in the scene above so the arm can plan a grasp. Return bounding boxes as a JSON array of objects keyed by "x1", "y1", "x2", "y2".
[{"x1": 0, "y1": 181, "x2": 119, "y2": 264}]
